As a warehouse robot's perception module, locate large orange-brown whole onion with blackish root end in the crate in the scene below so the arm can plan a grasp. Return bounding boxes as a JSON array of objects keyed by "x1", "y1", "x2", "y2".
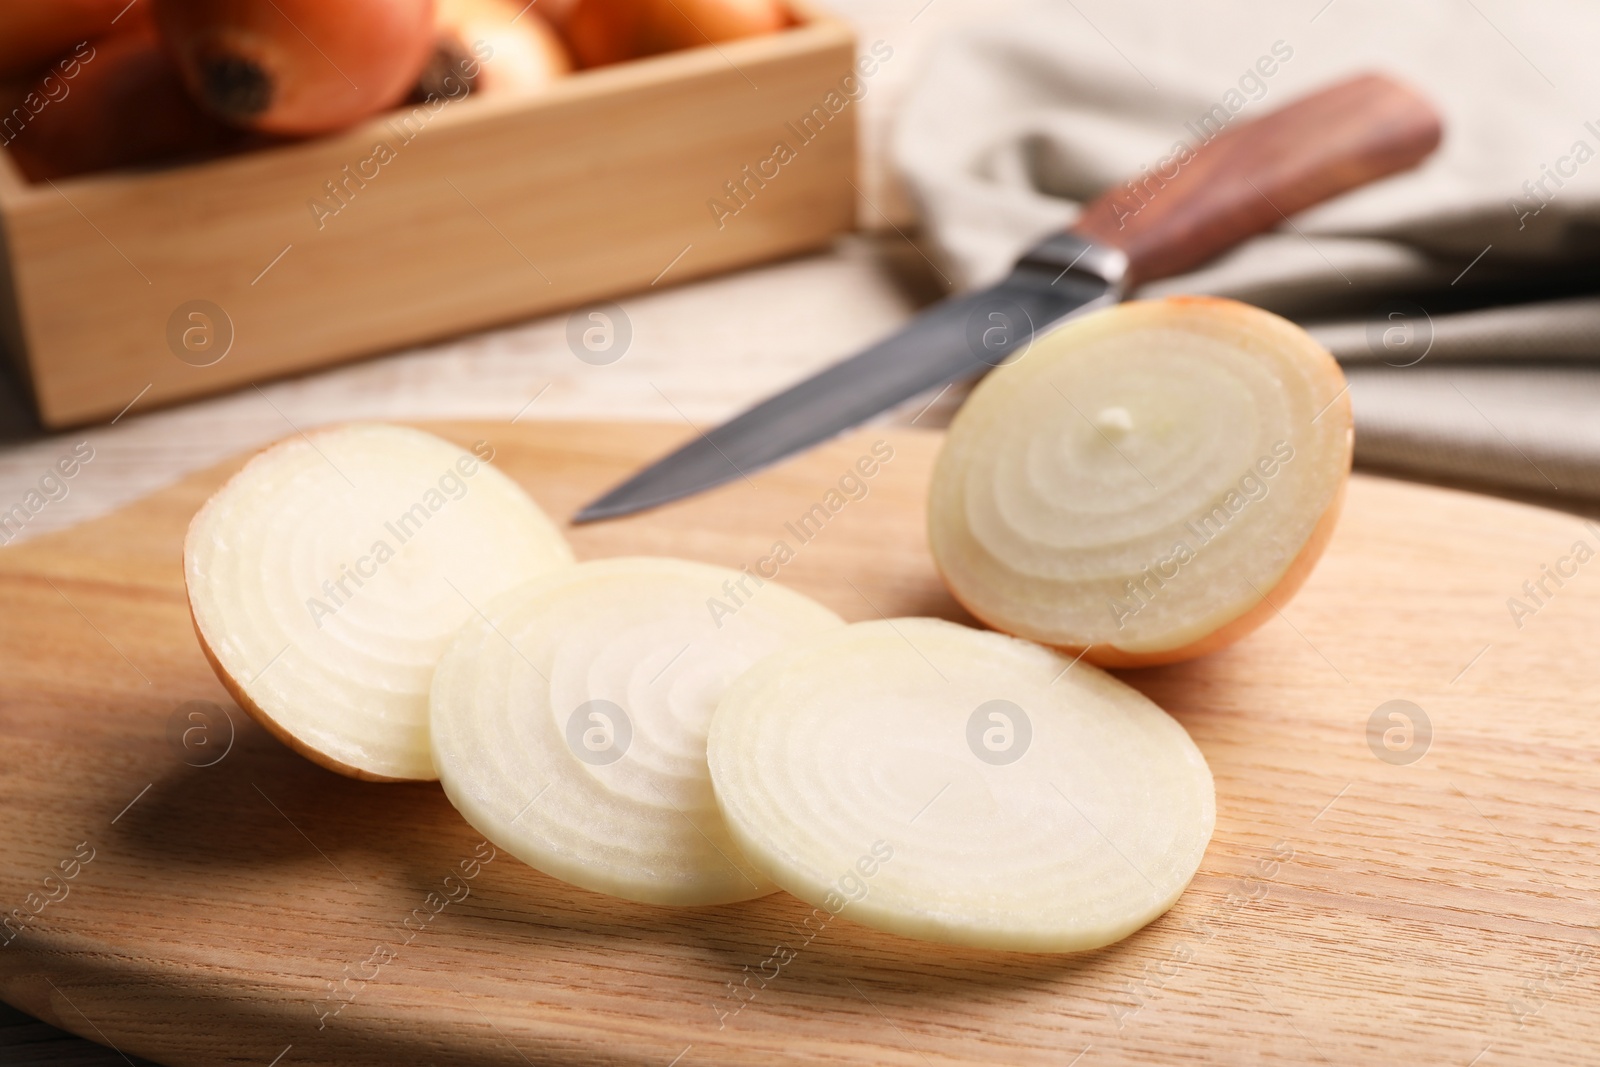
[{"x1": 155, "y1": 0, "x2": 434, "y2": 134}]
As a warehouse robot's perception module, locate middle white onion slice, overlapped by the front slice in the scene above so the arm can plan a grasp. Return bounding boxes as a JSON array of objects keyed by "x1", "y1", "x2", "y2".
[{"x1": 432, "y1": 558, "x2": 842, "y2": 904}]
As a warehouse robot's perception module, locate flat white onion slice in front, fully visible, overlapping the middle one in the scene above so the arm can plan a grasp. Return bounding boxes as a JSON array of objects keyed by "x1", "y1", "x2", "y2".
[{"x1": 707, "y1": 619, "x2": 1216, "y2": 952}]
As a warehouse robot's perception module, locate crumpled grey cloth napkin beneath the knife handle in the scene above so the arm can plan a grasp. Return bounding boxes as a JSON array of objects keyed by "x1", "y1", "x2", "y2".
[{"x1": 893, "y1": 0, "x2": 1600, "y2": 499}]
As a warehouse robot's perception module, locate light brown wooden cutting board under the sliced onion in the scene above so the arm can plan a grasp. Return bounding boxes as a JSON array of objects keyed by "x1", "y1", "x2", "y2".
[{"x1": 0, "y1": 424, "x2": 1600, "y2": 1067}]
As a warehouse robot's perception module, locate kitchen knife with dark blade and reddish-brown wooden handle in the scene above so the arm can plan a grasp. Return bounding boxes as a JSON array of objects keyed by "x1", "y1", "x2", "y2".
[{"x1": 573, "y1": 74, "x2": 1440, "y2": 523}]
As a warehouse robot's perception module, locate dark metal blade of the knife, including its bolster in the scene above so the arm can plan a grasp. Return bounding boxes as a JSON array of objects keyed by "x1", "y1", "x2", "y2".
[{"x1": 573, "y1": 232, "x2": 1128, "y2": 523}]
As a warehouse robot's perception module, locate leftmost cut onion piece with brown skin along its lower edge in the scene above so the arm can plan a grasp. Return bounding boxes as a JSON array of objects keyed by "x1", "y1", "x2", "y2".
[{"x1": 184, "y1": 426, "x2": 573, "y2": 781}]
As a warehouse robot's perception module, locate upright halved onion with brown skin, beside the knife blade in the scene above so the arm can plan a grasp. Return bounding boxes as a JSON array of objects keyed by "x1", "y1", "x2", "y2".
[{"x1": 928, "y1": 298, "x2": 1352, "y2": 665}]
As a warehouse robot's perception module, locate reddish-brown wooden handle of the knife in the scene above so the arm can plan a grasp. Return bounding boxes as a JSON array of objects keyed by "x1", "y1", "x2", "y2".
[{"x1": 1072, "y1": 74, "x2": 1440, "y2": 288}]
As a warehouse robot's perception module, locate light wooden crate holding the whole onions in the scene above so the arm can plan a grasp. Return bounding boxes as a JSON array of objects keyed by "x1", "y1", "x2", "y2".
[{"x1": 0, "y1": 10, "x2": 870, "y2": 427}]
